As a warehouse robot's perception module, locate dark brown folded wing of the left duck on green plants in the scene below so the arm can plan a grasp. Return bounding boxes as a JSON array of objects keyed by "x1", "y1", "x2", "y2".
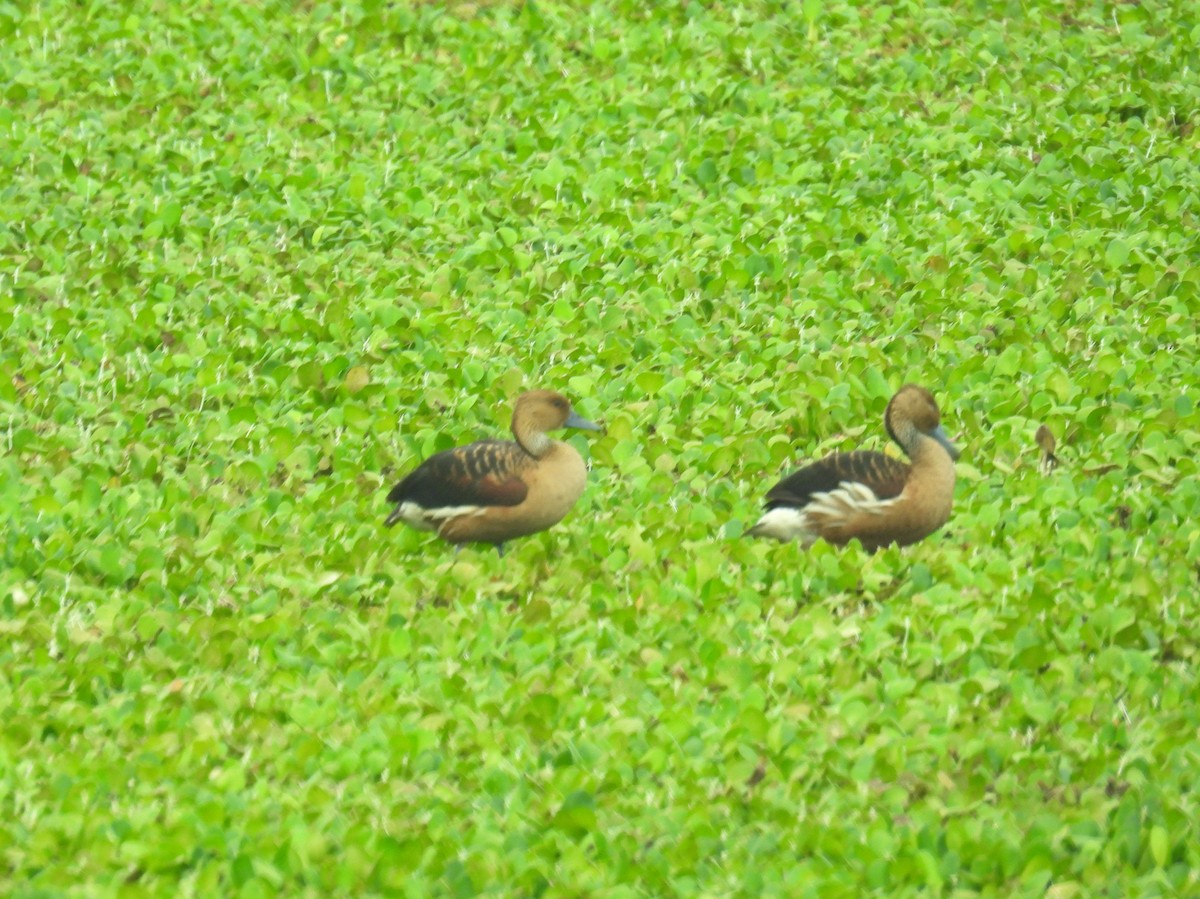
[{"x1": 388, "y1": 440, "x2": 530, "y2": 509}]
